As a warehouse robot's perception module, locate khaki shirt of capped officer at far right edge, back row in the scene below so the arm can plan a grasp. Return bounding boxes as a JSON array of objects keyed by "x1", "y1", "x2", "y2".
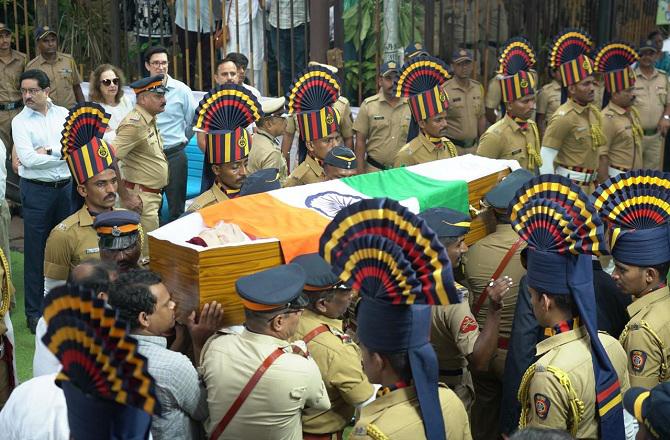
[{"x1": 633, "y1": 67, "x2": 670, "y2": 130}]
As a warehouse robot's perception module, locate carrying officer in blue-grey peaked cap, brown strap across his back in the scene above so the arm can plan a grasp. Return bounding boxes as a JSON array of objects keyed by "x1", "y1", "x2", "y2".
[{"x1": 200, "y1": 264, "x2": 330, "y2": 440}]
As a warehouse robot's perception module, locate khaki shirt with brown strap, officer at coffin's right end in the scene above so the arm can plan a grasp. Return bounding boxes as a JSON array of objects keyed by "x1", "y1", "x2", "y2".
[{"x1": 463, "y1": 224, "x2": 526, "y2": 339}]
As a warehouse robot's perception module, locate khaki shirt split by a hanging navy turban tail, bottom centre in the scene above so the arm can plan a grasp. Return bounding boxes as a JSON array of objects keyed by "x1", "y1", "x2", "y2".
[{"x1": 349, "y1": 384, "x2": 472, "y2": 440}]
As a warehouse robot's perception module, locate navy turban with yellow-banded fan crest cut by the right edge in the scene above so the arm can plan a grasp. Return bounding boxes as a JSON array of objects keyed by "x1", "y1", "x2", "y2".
[{"x1": 593, "y1": 170, "x2": 670, "y2": 267}]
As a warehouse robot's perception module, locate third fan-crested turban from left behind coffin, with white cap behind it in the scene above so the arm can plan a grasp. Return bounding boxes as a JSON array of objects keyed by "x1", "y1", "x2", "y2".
[{"x1": 286, "y1": 65, "x2": 341, "y2": 141}]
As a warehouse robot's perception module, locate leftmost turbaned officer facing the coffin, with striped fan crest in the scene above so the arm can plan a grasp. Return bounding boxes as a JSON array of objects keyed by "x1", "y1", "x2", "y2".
[{"x1": 44, "y1": 102, "x2": 118, "y2": 294}]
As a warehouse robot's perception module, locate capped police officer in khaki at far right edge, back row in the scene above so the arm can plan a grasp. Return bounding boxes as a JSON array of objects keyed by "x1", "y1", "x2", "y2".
[{"x1": 633, "y1": 40, "x2": 670, "y2": 170}]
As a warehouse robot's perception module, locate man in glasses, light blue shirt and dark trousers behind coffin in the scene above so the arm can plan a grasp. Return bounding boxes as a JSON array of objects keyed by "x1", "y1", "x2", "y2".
[{"x1": 144, "y1": 46, "x2": 197, "y2": 223}]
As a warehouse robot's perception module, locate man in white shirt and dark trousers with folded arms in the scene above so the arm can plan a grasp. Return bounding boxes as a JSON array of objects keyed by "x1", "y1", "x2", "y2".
[{"x1": 12, "y1": 69, "x2": 72, "y2": 333}]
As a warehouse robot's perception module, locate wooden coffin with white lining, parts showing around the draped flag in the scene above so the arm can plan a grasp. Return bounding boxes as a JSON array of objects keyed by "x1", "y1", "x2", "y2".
[{"x1": 148, "y1": 156, "x2": 518, "y2": 325}]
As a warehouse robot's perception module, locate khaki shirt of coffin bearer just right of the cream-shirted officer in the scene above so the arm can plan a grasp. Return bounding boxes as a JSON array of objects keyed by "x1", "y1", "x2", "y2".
[{"x1": 293, "y1": 310, "x2": 374, "y2": 434}]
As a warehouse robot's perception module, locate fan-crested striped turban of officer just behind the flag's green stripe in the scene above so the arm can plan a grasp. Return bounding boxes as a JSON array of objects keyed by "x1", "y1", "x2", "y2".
[{"x1": 394, "y1": 55, "x2": 451, "y2": 142}]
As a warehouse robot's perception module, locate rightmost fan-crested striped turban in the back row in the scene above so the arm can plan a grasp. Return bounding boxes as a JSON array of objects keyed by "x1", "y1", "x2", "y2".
[{"x1": 595, "y1": 41, "x2": 639, "y2": 107}]
